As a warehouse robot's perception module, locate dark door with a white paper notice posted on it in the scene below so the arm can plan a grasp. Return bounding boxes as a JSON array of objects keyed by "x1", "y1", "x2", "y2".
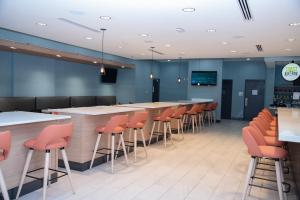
[{"x1": 244, "y1": 80, "x2": 265, "y2": 120}]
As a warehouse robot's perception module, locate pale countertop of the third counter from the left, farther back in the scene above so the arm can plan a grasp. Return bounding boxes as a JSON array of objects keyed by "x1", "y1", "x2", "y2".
[{"x1": 117, "y1": 102, "x2": 182, "y2": 109}]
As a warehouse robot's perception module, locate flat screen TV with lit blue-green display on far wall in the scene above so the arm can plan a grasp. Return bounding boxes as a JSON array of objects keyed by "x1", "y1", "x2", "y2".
[{"x1": 191, "y1": 71, "x2": 217, "y2": 85}]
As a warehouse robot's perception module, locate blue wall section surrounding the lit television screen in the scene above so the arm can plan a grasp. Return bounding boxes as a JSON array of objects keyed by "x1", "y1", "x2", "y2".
[{"x1": 187, "y1": 59, "x2": 223, "y2": 119}]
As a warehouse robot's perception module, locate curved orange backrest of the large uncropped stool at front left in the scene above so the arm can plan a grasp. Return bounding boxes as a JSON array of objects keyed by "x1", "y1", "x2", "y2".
[{"x1": 35, "y1": 123, "x2": 73, "y2": 150}]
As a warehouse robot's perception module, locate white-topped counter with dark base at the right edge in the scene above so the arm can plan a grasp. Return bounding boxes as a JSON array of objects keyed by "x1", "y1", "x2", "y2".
[{"x1": 277, "y1": 108, "x2": 300, "y2": 196}]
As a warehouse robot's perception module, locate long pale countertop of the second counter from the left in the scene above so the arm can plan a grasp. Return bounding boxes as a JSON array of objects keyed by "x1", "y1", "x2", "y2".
[{"x1": 43, "y1": 106, "x2": 144, "y2": 115}]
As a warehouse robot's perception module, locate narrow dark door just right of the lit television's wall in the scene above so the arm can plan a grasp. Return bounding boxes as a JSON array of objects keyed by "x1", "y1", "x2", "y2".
[{"x1": 221, "y1": 80, "x2": 232, "y2": 119}]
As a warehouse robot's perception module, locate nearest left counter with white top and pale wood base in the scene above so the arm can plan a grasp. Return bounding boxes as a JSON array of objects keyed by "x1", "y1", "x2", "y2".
[{"x1": 0, "y1": 111, "x2": 70, "y2": 197}]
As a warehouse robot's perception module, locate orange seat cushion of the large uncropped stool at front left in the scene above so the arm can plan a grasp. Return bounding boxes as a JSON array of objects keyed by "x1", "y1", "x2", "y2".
[{"x1": 24, "y1": 139, "x2": 67, "y2": 151}]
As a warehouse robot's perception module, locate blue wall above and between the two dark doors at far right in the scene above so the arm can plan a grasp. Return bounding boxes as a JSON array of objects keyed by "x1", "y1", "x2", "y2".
[{"x1": 223, "y1": 60, "x2": 272, "y2": 118}]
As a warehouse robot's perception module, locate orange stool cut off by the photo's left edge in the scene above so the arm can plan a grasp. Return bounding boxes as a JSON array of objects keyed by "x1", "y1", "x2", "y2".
[{"x1": 0, "y1": 131, "x2": 11, "y2": 200}]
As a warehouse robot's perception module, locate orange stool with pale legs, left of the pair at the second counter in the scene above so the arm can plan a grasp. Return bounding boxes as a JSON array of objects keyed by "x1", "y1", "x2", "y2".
[{"x1": 90, "y1": 115, "x2": 128, "y2": 173}]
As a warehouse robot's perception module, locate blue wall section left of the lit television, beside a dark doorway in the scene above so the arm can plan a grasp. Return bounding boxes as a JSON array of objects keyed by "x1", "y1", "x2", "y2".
[{"x1": 159, "y1": 62, "x2": 188, "y2": 101}]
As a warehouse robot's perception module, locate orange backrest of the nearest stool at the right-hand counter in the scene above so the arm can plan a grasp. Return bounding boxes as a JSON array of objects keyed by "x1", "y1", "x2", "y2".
[{"x1": 243, "y1": 126, "x2": 262, "y2": 157}]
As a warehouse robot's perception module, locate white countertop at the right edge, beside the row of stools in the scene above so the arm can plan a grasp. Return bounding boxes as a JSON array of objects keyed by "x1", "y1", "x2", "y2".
[{"x1": 277, "y1": 108, "x2": 300, "y2": 143}]
